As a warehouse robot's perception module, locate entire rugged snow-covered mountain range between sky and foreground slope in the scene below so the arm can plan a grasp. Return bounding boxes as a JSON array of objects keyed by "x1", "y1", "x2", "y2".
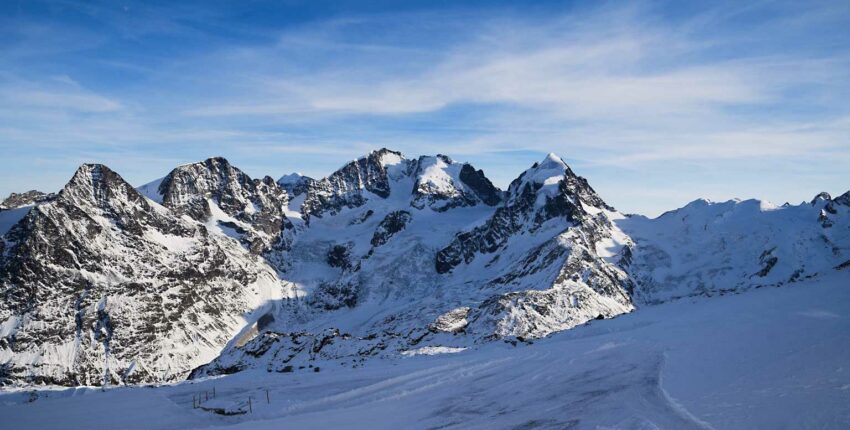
[{"x1": 0, "y1": 149, "x2": 850, "y2": 385}]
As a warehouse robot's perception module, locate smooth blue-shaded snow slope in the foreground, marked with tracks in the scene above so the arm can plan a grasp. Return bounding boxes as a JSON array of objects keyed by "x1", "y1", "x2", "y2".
[{"x1": 0, "y1": 272, "x2": 850, "y2": 430}]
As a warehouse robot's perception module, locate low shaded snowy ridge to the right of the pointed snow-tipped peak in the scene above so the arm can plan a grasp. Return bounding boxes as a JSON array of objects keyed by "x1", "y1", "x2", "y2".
[{"x1": 617, "y1": 193, "x2": 850, "y2": 303}]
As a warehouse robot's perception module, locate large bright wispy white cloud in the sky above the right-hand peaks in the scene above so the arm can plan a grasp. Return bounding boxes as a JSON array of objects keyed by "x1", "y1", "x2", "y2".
[{"x1": 174, "y1": 3, "x2": 850, "y2": 163}]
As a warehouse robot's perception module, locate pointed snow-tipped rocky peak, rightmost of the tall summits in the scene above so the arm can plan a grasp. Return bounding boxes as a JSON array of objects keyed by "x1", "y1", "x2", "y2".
[{"x1": 428, "y1": 154, "x2": 634, "y2": 338}]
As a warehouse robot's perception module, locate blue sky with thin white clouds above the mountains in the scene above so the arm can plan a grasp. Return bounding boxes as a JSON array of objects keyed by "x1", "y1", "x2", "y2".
[{"x1": 0, "y1": 0, "x2": 850, "y2": 215}]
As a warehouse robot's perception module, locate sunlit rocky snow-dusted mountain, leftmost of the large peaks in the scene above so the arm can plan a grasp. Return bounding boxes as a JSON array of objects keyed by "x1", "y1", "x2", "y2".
[{"x1": 0, "y1": 164, "x2": 282, "y2": 385}]
